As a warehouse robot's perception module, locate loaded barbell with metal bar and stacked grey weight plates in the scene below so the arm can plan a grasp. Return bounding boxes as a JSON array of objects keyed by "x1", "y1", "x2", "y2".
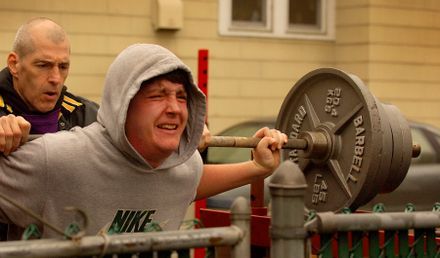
[{"x1": 207, "y1": 68, "x2": 421, "y2": 212}]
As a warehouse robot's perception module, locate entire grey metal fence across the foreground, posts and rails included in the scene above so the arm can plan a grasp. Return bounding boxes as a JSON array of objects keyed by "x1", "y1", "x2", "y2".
[{"x1": 0, "y1": 161, "x2": 440, "y2": 258}]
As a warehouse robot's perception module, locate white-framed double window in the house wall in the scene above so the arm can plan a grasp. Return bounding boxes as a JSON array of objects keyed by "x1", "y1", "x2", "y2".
[{"x1": 218, "y1": 0, "x2": 335, "y2": 39}]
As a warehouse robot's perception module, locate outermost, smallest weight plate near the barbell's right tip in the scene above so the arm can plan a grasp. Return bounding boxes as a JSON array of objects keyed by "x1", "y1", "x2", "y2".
[{"x1": 381, "y1": 104, "x2": 412, "y2": 193}]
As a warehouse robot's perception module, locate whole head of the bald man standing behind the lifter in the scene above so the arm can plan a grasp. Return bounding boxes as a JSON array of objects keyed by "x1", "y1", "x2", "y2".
[{"x1": 7, "y1": 18, "x2": 70, "y2": 113}]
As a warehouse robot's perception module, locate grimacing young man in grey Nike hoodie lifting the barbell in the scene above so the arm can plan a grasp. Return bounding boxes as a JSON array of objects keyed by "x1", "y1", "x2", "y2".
[{"x1": 0, "y1": 44, "x2": 287, "y2": 239}]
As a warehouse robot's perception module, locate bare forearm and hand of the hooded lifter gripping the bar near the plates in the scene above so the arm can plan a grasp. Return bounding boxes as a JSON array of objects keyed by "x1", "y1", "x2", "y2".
[{"x1": 196, "y1": 127, "x2": 287, "y2": 199}]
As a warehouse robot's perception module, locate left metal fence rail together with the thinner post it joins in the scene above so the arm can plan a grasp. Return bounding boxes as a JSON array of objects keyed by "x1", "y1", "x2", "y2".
[{"x1": 0, "y1": 197, "x2": 250, "y2": 258}]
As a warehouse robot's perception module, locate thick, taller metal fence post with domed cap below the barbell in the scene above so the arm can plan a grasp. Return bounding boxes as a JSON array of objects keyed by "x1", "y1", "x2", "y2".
[{"x1": 269, "y1": 160, "x2": 307, "y2": 258}]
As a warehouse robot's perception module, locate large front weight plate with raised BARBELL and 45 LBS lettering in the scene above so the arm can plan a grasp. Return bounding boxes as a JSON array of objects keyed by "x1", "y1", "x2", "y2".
[{"x1": 276, "y1": 68, "x2": 391, "y2": 212}]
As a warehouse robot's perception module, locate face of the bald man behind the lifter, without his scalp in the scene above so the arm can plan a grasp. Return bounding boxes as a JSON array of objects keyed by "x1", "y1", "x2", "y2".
[{"x1": 8, "y1": 35, "x2": 70, "y2": 112}]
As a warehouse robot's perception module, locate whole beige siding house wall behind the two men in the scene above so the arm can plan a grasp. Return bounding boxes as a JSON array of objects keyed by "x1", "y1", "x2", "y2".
[{"x1": 0, "y1": 0, "x2": 440, "y2": 133}]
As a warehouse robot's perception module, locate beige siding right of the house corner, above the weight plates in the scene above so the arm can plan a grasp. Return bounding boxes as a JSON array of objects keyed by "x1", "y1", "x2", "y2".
[{"x1": 369, "y1": 1, "x2": 440, "y2": 126}]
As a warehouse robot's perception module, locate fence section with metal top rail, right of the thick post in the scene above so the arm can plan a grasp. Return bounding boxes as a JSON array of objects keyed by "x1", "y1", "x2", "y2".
[{"x1": 305, "y1": 212, "x2": 440, "y2": 258}]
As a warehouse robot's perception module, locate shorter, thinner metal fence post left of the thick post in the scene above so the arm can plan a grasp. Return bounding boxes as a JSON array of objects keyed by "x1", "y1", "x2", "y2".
[{"x1": 231, "y1": 196, "x2": 251, "y2": 258}]
